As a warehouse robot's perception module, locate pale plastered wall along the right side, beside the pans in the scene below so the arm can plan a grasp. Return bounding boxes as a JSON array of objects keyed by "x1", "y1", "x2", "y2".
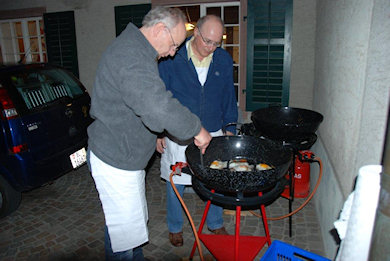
[{"x1": 313, "y1": 0, "x2": 390, "y2": 258}]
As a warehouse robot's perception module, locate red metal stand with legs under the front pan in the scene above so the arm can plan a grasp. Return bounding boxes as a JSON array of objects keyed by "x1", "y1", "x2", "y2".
[{"x1": 190, "y1": 192, "x2": 271, "y2": 261}]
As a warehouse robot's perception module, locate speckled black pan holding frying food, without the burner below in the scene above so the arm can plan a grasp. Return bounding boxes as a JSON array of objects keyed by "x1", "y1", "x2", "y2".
[{"x1": 185, "y1": 136, "x2": 292, "y2": 193}]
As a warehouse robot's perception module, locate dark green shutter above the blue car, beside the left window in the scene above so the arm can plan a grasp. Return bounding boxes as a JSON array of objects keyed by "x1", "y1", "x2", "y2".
[{"x1": 43, "y1": 11, "x2": 79, "y2": 77}]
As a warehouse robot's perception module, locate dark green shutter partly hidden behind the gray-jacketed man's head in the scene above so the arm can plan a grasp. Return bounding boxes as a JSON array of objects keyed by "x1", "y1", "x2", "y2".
[{"x1": 115, "y1": 4, "x2": 151, "y2": 36}]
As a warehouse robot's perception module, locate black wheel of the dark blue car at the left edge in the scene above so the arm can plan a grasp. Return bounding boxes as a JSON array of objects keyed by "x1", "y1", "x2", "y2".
[{"x1": 0, "y1": 176, "x2": 22, "y2": 218}]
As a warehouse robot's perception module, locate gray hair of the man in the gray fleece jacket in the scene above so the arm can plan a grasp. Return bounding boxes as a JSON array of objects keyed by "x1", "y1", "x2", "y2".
[{"x1": 142, "y1": 6, "x2": 187, "y2": 29}]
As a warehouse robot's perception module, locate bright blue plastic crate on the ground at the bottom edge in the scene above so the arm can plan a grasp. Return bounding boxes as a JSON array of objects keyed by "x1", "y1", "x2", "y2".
[{"x1": 260, "y1": 240, "x2": 330, "y2": 261}]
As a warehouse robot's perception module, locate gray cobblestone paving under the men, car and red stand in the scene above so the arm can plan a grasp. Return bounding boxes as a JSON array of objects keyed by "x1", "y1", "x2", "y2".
[{"x1": 0, "y1": 153, "x2": 324, "y2": 261}]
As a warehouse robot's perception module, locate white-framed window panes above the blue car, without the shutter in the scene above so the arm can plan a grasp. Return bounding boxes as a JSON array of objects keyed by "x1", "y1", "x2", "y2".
[{"x1": 0, "y1": 17, "x2": 47, "y2": 64}]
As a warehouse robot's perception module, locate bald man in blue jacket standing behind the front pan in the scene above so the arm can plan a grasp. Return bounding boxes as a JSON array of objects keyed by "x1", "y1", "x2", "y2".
[{"x1": 157, "y1": 15, "x2": 237, "y2": 246}]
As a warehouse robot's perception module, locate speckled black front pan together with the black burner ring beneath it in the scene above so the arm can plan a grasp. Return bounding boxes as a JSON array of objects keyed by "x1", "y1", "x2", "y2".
[{"x1": 185, "y1": 136, "x2": 292, "y2": 208}]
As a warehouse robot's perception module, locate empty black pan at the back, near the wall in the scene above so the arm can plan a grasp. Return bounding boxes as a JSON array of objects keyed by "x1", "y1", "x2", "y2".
[{"x1": 251, "y1": 107, "x2": 324, "y2": 140}]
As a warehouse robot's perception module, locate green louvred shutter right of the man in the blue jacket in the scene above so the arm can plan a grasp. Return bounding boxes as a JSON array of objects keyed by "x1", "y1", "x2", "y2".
[{"x1": 246, "y1": 0, "x2": 292, "y2": 111}]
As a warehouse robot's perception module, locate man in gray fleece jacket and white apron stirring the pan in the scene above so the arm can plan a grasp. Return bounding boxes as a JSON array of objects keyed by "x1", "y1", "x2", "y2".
[{"x1": 88, "y1": 7, "x2": 211, "y2": 260}]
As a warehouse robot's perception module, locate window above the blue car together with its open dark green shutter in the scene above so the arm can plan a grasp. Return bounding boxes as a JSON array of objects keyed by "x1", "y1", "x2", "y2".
[{"x1": 0, "y1": 8, "x2": 79, "y2": 77}]
